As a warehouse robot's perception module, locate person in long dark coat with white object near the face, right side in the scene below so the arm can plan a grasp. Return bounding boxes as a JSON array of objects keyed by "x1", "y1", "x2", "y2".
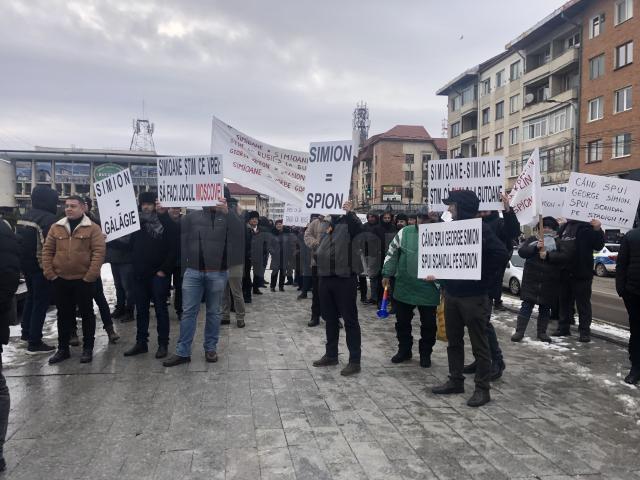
[{"x1": 511, "y1": 217, "x2": 566, "y2": 343}]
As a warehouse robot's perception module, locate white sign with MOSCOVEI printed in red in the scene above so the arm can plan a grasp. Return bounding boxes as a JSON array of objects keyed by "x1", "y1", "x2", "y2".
[{"x1": 158, "y1": 155, "x2": 224, "y2": 207}]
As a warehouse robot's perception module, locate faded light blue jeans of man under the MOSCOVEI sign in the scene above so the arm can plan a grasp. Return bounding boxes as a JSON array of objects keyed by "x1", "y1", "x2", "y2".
[{"x1": 176, "y1": 268, "x2": 228, "y2": 357}]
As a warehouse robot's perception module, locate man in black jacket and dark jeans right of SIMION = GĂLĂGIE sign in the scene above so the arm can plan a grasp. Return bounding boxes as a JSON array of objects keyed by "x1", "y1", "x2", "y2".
[{"x1": 124, "y1": 192, "x2": 177, "y2": 358}]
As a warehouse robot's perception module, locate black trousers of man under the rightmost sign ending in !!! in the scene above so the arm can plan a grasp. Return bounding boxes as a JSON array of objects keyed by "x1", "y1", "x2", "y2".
[{"x1": 558, "y1": 276, "x2": 593, "y2": 333}]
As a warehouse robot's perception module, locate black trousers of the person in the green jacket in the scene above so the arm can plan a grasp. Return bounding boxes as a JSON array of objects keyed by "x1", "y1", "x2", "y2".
[{"x1": 394, "y1": 299, "x2": 437, "y2": 356}]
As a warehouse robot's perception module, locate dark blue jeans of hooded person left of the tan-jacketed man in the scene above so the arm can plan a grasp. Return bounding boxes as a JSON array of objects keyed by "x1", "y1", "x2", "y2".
[{"x1": 22, "y1": 271, "x2": 52, "y2": 346}]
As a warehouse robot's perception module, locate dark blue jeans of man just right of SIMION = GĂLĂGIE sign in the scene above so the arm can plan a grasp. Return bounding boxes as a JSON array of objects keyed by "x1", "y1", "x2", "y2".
[{"x1": 134, "y1": 275, "x2": 169, "y2": 346}]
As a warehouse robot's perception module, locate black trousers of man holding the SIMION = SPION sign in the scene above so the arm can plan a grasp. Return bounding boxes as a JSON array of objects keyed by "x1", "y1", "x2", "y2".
[{"x1": 318, "y1": 276, "x2": 361, "y2": 363}]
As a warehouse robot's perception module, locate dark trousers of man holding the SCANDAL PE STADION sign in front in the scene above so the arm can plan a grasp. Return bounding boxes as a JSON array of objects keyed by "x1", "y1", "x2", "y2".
[{"x1": 444, "y1": 295, "x2": 491, "y2": 390}]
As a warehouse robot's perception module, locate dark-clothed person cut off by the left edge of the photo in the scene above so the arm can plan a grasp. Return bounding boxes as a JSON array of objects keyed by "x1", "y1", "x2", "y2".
[{"x1": 0, "y1": 218, "x2": 19, "y2": 472}]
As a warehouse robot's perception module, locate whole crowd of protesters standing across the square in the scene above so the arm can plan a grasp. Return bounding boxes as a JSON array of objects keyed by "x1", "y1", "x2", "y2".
[{"x1": 0, "y1": 186, "x2": 640, "y2": 467}]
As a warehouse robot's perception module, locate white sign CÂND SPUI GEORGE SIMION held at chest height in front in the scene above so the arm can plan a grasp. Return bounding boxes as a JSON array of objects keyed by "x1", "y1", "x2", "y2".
[{"x1": 418, "y1": 218, "x2": 482, "y2": 280}]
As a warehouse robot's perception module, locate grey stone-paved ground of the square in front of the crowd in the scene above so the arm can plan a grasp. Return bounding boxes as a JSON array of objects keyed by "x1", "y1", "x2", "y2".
[{"x1": 4, "y1": 268, "x2": 640, "y2": 480}]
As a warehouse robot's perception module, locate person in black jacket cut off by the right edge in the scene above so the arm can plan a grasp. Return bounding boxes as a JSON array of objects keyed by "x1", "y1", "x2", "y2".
[{"x1": 616, "y1": 227, "x2": 640, "y2": 385}]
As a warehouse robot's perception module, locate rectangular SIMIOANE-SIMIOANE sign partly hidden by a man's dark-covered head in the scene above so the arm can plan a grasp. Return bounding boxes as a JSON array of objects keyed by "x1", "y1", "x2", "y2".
[{"x1": 427, "y1": 157, "x2": 504, "y2": 212}]
